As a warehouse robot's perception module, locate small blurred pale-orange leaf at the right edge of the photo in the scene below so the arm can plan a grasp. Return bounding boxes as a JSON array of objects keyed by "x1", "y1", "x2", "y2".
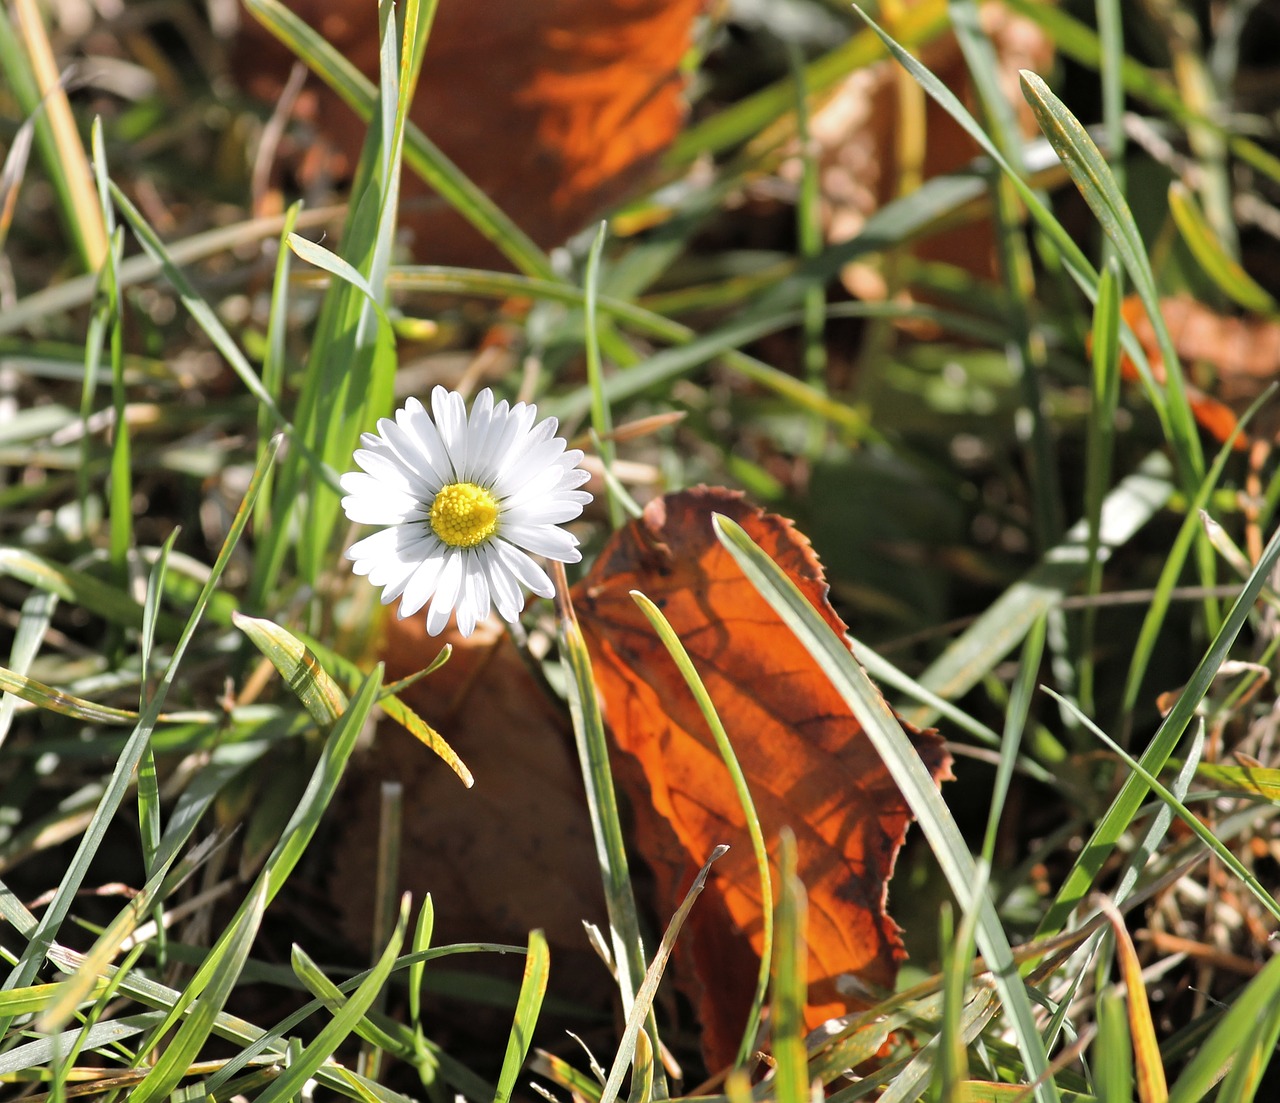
[{"x1": 1120, "y1": 294, "x2": 1280, "y2": 450}]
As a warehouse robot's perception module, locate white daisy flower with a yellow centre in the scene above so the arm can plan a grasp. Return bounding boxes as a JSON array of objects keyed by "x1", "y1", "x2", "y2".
[{"x1": 342, "y1": 386, "x2": 591, "y2": 636}]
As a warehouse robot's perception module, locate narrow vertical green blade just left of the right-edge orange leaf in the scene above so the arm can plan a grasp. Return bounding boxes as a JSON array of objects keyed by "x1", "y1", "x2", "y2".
[{"x1": 1076, "y1": 258, "x2": 1120, "y2": 715}]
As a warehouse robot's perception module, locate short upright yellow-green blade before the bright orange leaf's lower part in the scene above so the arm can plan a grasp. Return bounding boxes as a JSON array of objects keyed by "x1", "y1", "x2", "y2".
[{"x1": 772, "y1": 828, "x2": 810, "y2": 1103}]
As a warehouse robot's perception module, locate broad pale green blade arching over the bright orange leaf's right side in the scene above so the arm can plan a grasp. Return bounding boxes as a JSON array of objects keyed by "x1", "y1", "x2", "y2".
[{"x1": 713, "y1": 516, "x2": 1060, "y2": 1103}]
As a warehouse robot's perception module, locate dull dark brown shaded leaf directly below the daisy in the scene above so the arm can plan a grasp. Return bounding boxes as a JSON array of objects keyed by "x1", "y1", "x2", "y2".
[{"x1": 330, "y1": 617, "x2": 613, "y2": 1047}]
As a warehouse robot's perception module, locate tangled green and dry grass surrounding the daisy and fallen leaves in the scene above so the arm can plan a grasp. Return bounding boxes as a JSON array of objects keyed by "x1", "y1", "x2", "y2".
[{"x1": 0, "y1": 0, "x2": 1280, "y2": 1103}]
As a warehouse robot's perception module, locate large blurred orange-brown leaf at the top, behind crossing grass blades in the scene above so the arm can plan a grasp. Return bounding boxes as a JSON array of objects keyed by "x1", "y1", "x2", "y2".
[{"x1": 237, "y1": 0, "x2": 705, "y2": 264}]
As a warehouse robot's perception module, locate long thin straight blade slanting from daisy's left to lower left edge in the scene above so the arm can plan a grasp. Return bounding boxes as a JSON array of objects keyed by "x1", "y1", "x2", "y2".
[{"x1": 0, "y1": 438, "x2": 279, "y2": 1035}]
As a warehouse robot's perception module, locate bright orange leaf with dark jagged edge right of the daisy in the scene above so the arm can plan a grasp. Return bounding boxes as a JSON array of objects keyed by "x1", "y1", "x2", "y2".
[{"x1": 573, "y1": 488, "x2": 950, "y2": 1068}]
